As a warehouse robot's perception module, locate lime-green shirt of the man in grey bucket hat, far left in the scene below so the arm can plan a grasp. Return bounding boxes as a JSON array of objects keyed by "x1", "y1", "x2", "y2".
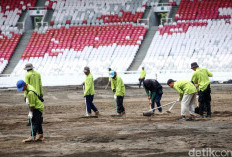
[{"x1": 24, "y1": 70, "x2": 43, "y2": 97}]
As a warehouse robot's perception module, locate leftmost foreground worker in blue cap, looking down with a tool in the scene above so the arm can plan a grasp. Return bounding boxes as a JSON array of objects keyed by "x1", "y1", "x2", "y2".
[{"x1": 17, "y1": 80, "x2": 44, "y2": 143}]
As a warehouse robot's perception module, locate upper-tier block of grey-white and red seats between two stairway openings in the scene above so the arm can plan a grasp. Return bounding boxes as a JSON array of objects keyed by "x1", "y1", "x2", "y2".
[{"x1": 45, "y1": 0, "x2": 146, "y2": 25}]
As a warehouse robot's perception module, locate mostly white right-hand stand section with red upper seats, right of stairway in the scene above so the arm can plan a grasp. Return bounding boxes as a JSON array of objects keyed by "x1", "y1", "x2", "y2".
[{"x1": 139, "y1": 0, "x2": 232, "y2": 82}]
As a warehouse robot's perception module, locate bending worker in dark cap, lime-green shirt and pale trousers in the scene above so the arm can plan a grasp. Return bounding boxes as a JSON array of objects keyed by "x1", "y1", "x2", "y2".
[{"x1": 167, "y1": 79, "x2": 197, "y2": 120}]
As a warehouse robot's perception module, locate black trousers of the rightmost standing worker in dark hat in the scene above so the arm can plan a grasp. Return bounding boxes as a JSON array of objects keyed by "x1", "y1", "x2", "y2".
[{"x1": 198, "y1": 85, "x2": 211, "y2": 115}]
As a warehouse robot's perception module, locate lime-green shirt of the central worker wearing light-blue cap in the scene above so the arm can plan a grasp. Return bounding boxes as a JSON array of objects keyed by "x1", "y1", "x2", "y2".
[{"x1": 111, "y1": 75, "x2": 125, "y2": 96}]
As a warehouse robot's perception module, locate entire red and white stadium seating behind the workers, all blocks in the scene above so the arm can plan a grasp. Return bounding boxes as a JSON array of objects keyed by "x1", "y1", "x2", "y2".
[{"x1": 0, "y1": 0, "x2": 232, "y2": 85}]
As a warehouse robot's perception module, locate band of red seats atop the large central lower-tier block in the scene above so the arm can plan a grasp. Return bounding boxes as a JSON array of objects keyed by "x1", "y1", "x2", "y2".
[{"x1": 21, "y1": 24, "x2": 147, "y2": 59}]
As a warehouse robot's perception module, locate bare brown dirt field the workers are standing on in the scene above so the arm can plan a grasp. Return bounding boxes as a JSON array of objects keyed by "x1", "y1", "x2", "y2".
[{"x1": 0, "y1": 85, "x2": 232, "y2": 157}]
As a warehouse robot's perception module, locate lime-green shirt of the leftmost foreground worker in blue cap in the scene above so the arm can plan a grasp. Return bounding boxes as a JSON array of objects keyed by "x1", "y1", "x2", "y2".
[{"x1": 25, "y1": 84, "x2": 44, "y2": 112}]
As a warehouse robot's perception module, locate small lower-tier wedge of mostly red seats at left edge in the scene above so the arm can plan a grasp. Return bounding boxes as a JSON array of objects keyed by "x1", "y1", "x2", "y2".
[{"x1": 0, "y1": 32, "x2": 21, "y2": 74}]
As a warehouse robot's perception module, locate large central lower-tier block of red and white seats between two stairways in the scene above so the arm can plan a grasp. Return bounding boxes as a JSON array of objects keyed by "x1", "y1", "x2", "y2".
[{"x1": 12, "y1": 24, "x2": 147, "y2": 75}]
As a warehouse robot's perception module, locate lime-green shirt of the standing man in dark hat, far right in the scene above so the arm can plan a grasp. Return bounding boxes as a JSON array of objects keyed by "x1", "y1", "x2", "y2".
[{"x1": 191, "y1": 68, "x2": 213, "y2": 91}]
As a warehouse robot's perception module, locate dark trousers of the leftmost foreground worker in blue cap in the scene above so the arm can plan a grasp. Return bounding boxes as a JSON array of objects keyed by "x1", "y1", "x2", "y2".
[{"x1": 32, "y1": 109, "x2": 43, "y2": 136}]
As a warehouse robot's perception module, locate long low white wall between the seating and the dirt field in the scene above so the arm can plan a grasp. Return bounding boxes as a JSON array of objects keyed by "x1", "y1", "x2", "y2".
[{"x1": 0, "y1": 72, "x2": 232, "y2": 88}]
